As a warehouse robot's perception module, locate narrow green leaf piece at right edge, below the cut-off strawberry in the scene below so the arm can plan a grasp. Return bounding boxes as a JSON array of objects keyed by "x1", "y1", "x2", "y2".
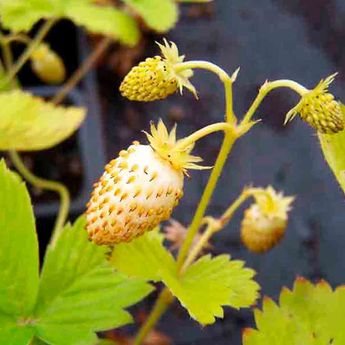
[{"x1": 318, "y1": 104, "x2": 345, "y2": 193}]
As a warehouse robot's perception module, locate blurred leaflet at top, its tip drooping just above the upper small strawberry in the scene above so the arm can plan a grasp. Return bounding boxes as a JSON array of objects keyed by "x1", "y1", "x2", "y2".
[{"x1": 66, "y1": 1, "x2": 140, "y2": 46}]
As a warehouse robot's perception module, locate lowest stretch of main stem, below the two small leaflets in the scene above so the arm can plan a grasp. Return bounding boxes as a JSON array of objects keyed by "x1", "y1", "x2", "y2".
[{"x1": 133, "y1": 288, "x2": 174, "y2": 345}]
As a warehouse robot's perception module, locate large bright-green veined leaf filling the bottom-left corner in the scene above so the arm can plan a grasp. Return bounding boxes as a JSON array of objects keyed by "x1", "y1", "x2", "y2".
[{"x1": 0, "y1": 161, "x2": 152, "y2": 345}]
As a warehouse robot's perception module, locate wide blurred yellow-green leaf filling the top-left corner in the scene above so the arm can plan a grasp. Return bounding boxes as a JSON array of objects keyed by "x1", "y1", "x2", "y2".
[{"x1": 0, "y1": 0, "x2": 140, "y2": 45}]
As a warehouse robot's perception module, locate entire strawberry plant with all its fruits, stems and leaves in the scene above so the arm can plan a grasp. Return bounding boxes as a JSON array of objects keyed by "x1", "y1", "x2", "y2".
[{"x1": 0, "y1": 0, "x2": 344, "y2": 345}]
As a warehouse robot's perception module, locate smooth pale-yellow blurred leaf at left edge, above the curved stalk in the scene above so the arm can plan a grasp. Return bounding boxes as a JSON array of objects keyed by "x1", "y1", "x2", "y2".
[{"x1": 0, "y1": 90, "x2": 85, "y2": 151}]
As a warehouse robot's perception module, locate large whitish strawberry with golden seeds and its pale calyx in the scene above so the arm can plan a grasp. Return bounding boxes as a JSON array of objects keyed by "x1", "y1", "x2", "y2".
[{"x1": 86, "y1": 122, "x2": 206, "y2": 244}]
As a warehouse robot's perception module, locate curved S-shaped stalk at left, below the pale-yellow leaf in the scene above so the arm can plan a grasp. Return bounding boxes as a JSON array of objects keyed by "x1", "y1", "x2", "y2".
[{"x1": 9, "y1": 151, "x2": 70, "y2": 246}]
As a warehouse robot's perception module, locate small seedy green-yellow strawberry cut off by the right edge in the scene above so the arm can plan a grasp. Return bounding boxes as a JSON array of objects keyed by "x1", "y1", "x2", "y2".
[{"x1": 285, "y1": 74, "x2": 345, "y2": 134}]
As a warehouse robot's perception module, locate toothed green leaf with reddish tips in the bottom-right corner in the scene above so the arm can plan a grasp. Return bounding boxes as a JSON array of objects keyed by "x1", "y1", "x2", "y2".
[{"x1": 243, "y1": 278, "x2": 345, "y2": 345}]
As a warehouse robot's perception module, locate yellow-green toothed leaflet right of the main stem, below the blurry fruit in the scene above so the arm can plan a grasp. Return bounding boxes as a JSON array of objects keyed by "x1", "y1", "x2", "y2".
[{"x1": 161, "y1": 255, "x2": 259, "y2": 325}]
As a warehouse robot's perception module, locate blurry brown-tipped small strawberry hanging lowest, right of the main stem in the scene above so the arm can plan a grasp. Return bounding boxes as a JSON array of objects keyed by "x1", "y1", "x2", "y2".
[{"x1": 241, "y1": 187, "x2": 294, "y2": 253}]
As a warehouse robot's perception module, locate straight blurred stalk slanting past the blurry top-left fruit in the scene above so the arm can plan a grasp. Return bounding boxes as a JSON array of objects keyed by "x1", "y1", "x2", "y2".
[{"x1": 1, "y1": 18, "x2": 56, "y2": 86}]
